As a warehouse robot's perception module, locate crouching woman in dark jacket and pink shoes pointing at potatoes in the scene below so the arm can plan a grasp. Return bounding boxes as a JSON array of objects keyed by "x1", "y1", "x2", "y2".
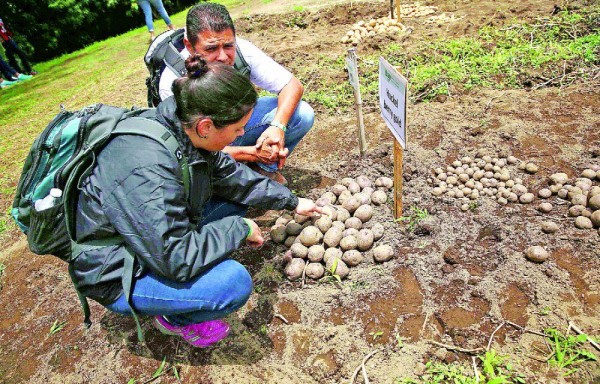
[{"x1": 69, "y1": 55, "x2": 322, "y2": 348}]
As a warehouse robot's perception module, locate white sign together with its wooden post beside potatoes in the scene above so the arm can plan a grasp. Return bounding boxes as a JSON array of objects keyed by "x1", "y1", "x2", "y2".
[{"x1": 379, "y1": 57, "x2": 408, "y2": 218}]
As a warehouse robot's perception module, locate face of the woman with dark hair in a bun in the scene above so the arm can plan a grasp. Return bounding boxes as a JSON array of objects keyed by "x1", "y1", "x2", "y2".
[{"x1": 186, "y1": 110, "x2": 252, "y2": 152}]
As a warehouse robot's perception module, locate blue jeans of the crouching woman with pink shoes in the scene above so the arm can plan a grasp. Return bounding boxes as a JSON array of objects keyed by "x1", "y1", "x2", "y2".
[{"x1": 106, "y1": 199, "x2": 252, "y2": 325}]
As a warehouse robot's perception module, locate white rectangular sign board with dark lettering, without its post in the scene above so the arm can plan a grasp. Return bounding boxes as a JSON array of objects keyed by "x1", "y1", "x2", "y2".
[{"x1": 379, "y1": 57, "x2": 408, "y2": 149}]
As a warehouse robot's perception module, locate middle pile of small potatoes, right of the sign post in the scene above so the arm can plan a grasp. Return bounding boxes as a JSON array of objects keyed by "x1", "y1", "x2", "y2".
[{"x1": 429, "y1": 155, "x2": 538, "y2": 211}]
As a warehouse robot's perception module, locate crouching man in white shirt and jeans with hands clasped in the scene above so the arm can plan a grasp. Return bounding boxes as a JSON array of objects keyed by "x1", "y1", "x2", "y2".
[{"x1": 159, "y1": 3, "x2": 315, "y2": 185}]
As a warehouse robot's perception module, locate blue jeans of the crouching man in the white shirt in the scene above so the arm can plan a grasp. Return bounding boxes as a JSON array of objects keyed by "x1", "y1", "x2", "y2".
[{"x1": 231, "y1": 97, "x2": 315, "y2": 172}]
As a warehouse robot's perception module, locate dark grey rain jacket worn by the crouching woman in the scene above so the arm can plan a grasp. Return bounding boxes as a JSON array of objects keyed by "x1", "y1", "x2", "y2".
[{"x1": 70, "y1": 98, "x2": 298, "y2": 305}]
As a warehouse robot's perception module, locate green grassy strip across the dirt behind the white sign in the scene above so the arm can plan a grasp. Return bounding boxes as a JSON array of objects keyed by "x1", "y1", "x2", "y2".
[{"x1": 299, "y1": 9, "x2": 600, "y2": 110}]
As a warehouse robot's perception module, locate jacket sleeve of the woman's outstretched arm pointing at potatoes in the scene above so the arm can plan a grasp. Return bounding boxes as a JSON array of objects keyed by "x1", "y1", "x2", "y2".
[{"x1": 213, "y1": 152, "x2": 298, "y2": 210}]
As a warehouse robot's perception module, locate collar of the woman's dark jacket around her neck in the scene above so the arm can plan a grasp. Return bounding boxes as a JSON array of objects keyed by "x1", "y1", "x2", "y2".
[{"x1": 156, "y1": 96, "x2": 216, "y2": 165}]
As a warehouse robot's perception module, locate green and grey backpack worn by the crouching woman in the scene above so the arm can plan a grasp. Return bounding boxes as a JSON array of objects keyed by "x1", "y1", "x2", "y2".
[{"x1": 11, "y1": 104, "x2": 189, "y2": 339}]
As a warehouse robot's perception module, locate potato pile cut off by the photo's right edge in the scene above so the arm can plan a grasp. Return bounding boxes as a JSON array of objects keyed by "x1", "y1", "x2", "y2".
[{"x1": 538, "y1": 166, "x2": 600, "y2": 234}]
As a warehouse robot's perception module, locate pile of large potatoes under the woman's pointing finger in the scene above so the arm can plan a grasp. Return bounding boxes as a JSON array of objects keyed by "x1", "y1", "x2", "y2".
[{"x1": 271, "y1": 176, "x2": 394, "y2": 281}]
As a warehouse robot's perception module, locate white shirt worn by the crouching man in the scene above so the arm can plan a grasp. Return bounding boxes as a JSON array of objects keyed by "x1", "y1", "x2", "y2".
[{"x1": 158, "y1": 38, "x2": 293, "y2": 100}]
